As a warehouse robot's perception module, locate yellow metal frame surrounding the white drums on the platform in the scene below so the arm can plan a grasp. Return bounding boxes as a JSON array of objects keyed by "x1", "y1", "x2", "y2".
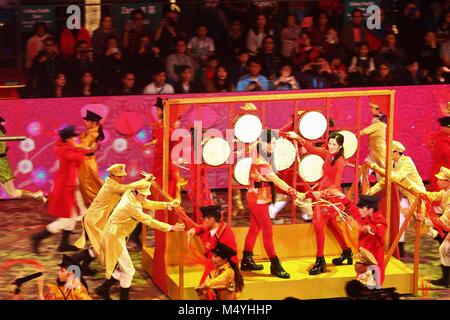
[{"x1": 162, "y1": 90, "x2": 395, "y2": 299}]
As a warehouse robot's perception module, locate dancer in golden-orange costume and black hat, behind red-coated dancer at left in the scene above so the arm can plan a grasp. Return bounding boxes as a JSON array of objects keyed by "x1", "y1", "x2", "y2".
[{"x1": 76, "y1": 110, "x2": 105, "y2": 207}]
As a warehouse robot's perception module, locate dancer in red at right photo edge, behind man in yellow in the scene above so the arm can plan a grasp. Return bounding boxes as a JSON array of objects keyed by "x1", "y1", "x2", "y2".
[{"x1": 428, "y1": 116, "x2": 450, "y2": 191}]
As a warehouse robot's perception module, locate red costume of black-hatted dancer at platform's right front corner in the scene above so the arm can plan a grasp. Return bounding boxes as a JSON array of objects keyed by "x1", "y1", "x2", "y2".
[{"x1": 342, "y1": 198, "x2": 387, "y2": 284}]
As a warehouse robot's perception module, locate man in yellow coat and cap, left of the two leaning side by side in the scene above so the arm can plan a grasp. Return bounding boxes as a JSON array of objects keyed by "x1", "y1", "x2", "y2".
[{"x1": 71, "y1": 164, "x2": 151, "y2": 275}]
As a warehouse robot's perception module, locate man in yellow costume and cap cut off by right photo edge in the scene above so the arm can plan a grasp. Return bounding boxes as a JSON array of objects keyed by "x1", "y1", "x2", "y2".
[{"x1": 425, "y1": 167, "x2": 450, "y2": 288}]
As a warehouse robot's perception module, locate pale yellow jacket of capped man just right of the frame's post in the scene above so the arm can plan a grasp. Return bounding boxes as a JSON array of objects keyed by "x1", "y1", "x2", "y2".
[{"x1": 369, "y1": 156, "x2": 426, "y2": 205}]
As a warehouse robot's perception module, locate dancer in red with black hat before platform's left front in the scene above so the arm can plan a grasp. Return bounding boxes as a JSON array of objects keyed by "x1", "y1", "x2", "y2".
[{"x1": 188, "y1": 205, "x2": 239, "y2": 284}]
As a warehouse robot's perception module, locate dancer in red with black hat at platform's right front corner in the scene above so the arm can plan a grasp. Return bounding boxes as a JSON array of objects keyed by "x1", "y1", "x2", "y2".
[{"x1": 326, "y1": 188, "x2": 387, "y2": 284}]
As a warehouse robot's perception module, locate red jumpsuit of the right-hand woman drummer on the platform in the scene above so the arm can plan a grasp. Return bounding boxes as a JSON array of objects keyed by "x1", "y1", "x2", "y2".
[{"x1": 304, "y1": 141, "x2": 348, "y2": 257}]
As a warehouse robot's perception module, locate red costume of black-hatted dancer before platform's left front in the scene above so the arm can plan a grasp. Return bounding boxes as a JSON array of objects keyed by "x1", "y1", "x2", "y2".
[{"x1": 195, "y1": 221, "x2": 239, "y2": 284}]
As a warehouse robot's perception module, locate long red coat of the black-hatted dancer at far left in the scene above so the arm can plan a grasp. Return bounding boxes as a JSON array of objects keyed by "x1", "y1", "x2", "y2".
[{"x1": 48, "y1": 141, "x2": 89, "y2": 218}]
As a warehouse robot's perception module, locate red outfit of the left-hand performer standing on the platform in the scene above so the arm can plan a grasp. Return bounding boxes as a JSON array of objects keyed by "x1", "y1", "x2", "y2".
[{"x1": 244, "y1": 158, "x2": 277, "y2": 258}]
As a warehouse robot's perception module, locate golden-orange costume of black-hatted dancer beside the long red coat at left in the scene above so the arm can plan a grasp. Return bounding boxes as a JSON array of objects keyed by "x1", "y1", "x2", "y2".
[{"x1": 76, "y1": 127, "x2": 103, "y2": 206}]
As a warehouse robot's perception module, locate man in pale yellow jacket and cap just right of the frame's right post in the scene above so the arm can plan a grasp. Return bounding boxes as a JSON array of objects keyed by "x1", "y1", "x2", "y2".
[{"x1": 368, "y1": 140, "x2": 426, "y2": 256}]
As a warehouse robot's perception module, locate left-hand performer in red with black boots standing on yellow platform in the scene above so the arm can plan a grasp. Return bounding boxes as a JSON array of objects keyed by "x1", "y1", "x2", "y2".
[{"x1": 241, "y1": 129, "x2": 305, "y2": 279}]
